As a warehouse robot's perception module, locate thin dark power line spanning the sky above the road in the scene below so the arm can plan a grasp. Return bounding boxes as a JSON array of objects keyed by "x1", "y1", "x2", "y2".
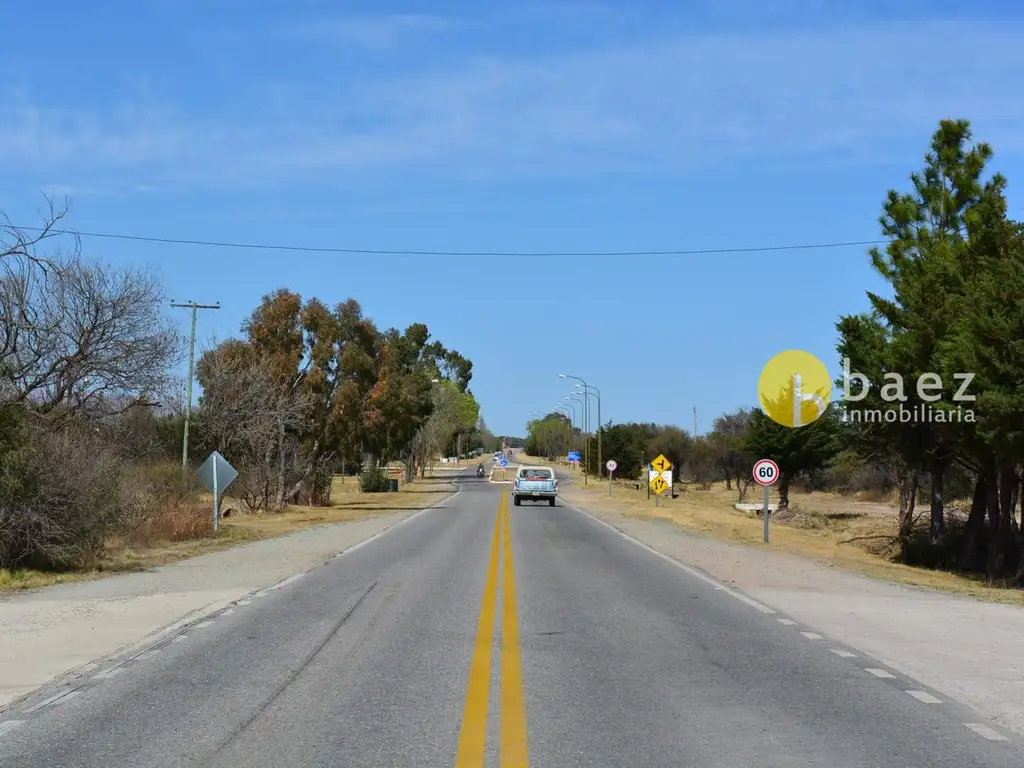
[{"x1": 9, "y1": 226, "x2": 888, "y2": 258}]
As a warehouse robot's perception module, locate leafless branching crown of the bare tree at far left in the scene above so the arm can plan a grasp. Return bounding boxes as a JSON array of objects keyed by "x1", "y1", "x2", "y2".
[{"x1": 0, "y1": 258, "x2": 183, "y2": 420}]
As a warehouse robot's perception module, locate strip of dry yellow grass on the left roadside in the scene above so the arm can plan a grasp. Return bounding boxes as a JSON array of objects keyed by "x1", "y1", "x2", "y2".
[{"x1": 0, "y1": 475, "x2": 454, "y2": 593}]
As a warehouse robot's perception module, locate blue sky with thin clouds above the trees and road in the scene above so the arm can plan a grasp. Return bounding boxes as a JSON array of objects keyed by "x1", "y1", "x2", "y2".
[{"x1": 0, "y1": 0, "x2": 1024, "y2": 433}]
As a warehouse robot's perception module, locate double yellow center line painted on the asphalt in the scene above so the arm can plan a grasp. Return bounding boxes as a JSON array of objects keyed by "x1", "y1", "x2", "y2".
[{"x1": 455, "y1": 493, "x2": 529, "y2": 768}]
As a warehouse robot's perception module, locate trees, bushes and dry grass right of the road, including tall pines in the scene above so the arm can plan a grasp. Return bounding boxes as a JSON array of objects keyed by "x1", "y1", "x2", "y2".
[{"x1": 525, "y1": 120, "x2": 1024, "y2": 589}]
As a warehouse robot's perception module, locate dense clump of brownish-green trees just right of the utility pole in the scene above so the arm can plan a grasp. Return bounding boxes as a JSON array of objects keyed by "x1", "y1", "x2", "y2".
[{"x1": 196, "y1": 289, "x2": 485, "y2": 509}]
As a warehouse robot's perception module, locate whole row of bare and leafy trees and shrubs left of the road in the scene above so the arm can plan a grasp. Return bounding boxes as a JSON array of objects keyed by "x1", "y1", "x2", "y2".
[{"x1": 0, "y1": 200, "x2": 483, "y2": 569}]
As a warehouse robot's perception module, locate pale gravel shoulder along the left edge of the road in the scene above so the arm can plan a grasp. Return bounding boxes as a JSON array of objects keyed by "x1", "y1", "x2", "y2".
[{"x1": 0, "y1": 485, "x2": 456, "y2": 711}]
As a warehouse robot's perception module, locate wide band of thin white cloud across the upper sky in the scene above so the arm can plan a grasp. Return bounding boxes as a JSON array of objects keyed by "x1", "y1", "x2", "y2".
[{"x1": 6, "y1": 22, "x2": 1024, "y2": 186}]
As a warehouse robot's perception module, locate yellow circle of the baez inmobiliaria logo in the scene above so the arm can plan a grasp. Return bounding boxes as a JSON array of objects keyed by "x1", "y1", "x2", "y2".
[{"x1": 758, "y1": 349, "x2": 833, "y2": 428}]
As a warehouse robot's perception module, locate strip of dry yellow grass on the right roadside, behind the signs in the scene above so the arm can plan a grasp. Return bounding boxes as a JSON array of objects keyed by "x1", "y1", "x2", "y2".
[{"x1": 530, "y1": 459, "x2": 1024, "y2": 604}]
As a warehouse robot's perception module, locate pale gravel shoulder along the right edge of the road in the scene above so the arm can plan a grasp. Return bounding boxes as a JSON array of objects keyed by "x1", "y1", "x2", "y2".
[{"x1": 562, "y1": 488, "x2": 1024, "y2": 734}]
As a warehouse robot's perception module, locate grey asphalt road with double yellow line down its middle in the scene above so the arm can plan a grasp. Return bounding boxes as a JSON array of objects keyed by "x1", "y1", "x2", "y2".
[{"x1": 0, "y1": 473, "x2": 1024, "y2": 768}]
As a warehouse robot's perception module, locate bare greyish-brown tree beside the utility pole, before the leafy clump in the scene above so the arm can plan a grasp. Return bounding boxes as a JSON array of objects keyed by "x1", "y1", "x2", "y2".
[{"x1": 197, "y1": 341, "x2": 310, "y2": 510}]
